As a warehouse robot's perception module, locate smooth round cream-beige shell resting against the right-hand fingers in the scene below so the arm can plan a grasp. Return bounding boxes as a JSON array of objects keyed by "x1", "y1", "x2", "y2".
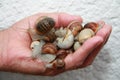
[{"x1": 78, "y1": 28, "x2": 95, "y2": 44}]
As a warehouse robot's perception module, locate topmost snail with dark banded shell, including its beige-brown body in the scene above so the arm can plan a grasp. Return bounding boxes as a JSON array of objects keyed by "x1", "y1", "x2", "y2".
[{"x1": 28, "y1": 16, "x2": 56, "y2": 42}]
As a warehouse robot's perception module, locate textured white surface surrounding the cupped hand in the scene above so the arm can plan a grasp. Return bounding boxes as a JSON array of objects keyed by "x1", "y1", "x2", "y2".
[{"x1": 0, "y1": 0, "x2": 120, "y2": 80}]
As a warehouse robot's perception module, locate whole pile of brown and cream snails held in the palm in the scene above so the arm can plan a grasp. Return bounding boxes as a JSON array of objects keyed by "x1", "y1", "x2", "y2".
[{"x1": 28, "y1": 16, "x2": 104, "y2": 69}]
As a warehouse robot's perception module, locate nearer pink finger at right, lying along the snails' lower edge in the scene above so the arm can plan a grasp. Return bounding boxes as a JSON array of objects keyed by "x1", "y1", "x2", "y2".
[{"x1": 65, "y1": 36, "x2": 103, "y2": 69}]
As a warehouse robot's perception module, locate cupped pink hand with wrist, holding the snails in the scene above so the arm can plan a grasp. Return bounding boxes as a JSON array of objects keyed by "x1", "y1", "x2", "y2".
[{"x1": 0, "y1": 13, "x2": 111, "y2": 76}]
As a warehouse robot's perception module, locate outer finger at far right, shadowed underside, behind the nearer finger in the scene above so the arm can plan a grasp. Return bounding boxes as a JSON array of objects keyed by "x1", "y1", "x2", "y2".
[{"x1": 80, "y1": 24, "x2": 112, "y2": 68}]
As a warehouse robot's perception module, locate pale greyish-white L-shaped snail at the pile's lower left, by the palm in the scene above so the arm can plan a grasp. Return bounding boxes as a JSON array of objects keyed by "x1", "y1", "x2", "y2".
[{"x1": 31, "y1": 40, "x2": 56, "y2": 62}]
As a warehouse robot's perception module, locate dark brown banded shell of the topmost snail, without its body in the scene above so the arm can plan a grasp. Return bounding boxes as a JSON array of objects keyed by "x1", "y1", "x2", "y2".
[{"x1": 36, "y1": 17, "x2": 55, "y2": 35}]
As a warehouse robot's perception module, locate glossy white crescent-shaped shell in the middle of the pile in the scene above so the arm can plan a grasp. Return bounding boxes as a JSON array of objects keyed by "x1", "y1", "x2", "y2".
[{"x1": 57, "y1": 29, "x2": 74, "y2": 49}]
